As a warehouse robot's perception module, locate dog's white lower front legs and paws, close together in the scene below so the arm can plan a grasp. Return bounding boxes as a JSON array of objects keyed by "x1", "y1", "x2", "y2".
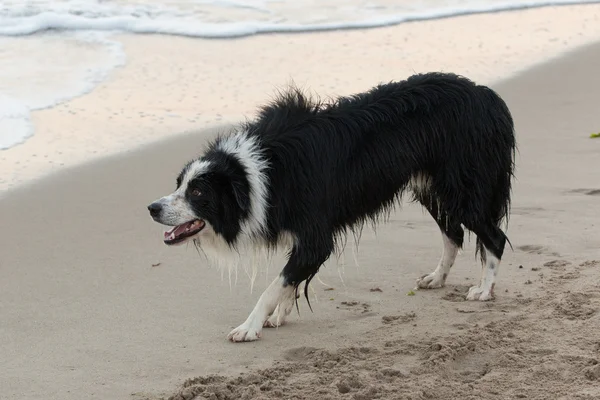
[{"x1": 227, "y1": 274, "x2": 296, "y2": 342}]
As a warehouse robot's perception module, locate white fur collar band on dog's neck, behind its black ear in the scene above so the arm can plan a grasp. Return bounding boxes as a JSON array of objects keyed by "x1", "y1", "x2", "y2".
[{"x1": 216, "y1": 132, "x2": 269, "y2": 235}]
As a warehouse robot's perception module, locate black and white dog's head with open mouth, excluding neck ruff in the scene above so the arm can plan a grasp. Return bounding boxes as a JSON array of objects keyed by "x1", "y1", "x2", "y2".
[{"x1": 148, "y1": 152, "x2": 250, "y2": 245}]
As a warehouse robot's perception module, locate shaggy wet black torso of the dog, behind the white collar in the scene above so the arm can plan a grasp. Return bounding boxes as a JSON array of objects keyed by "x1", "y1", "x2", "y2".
[{"x1": 250, "y1": 73, "x2": 515, "y2": 241}]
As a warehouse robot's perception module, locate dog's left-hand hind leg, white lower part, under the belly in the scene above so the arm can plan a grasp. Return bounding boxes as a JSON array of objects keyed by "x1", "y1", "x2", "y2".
[{"x1": 417, "y1": 202, "x2": 465, "y2": 289}]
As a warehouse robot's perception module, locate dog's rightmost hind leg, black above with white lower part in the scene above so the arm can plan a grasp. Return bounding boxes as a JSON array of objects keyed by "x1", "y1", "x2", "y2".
[{"x1": 467, "y1": 222, "x2": 506, "y2": 301}]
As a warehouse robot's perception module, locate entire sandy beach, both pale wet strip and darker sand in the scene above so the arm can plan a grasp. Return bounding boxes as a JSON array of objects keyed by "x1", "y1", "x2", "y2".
[{"x1": 0, "y1": 5, "x2": 600, "y2": 400}]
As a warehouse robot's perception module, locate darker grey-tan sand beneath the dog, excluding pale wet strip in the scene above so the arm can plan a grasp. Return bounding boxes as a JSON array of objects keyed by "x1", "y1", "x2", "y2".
[{"x1": 0, "y1": 9, "x2": 600, "y2": 400}]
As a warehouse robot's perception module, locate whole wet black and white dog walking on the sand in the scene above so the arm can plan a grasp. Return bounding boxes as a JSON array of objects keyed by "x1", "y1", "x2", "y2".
[{"x1": 148, "y1": 73, "x2": 516, "y2": 342}]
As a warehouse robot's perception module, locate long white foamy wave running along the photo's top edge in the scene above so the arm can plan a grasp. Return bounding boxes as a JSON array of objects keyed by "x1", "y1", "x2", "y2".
[{"x1": 0, "y1": 0, "x2": 600, "y2": 38}]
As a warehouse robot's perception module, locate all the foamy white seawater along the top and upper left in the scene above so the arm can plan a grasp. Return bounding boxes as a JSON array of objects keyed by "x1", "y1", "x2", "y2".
[{"x1": 0, "y1": 0, "x2": 600, "y2": 150}]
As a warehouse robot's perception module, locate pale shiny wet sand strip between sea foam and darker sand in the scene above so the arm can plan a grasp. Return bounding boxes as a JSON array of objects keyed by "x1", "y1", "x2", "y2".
[{"x1": 0, "y1": 4, "x2": 600, "y2": 196}]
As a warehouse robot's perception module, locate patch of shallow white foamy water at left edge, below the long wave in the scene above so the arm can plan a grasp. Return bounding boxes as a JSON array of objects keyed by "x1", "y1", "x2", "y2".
[{"x1": 0, "y1": 32, "x2": 125, "y2": 150}]
